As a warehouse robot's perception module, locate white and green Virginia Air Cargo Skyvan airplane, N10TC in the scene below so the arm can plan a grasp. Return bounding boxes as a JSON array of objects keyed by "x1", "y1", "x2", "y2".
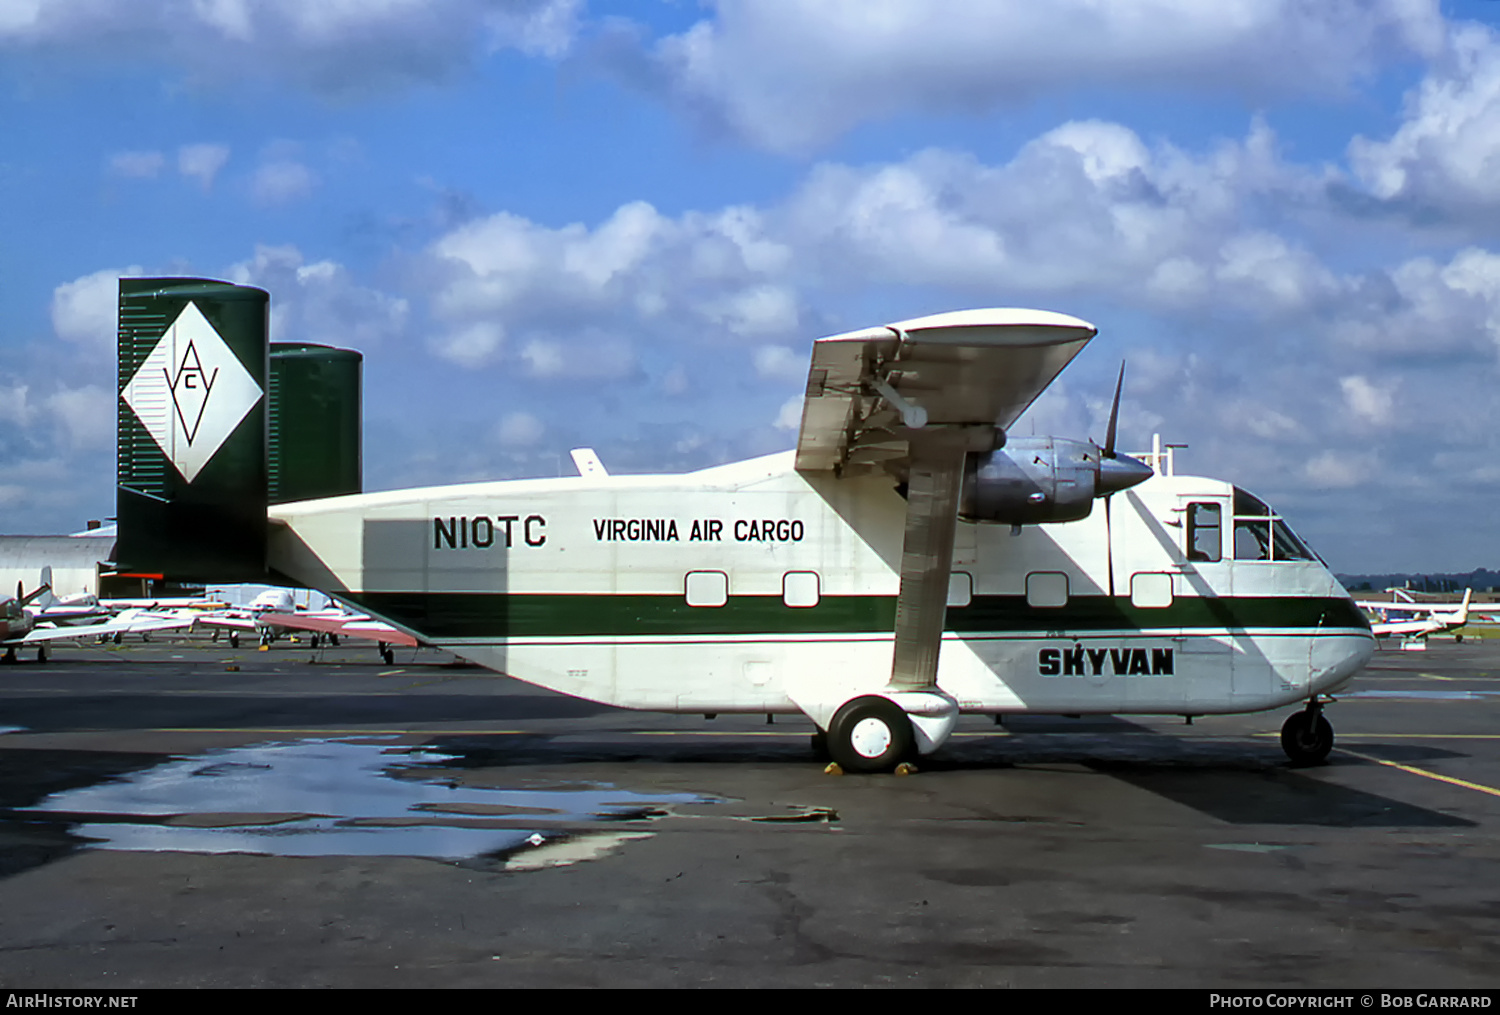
[{"x1": 117, "y1": 279, "x2": 1374, "y2": 771}]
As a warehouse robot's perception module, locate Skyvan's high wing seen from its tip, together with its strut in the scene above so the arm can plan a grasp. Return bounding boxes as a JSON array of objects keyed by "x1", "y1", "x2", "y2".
[{"x1": 797, "y1": 309, "x2": 1097, "y2": 701}]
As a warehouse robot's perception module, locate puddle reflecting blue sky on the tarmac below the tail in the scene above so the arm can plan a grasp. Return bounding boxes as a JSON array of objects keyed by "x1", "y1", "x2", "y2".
[{"x1": 26, "y1": 741, "x2": 719, "y2": 870}]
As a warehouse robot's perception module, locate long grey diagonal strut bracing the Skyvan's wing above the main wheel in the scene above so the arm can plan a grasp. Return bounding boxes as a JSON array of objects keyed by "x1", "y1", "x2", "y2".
[{"x1": 891, "y1": 426, "x2": 995, "y2": 691}]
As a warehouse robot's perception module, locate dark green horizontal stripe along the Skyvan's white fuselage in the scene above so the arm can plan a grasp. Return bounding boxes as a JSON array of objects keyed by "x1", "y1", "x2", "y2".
[{"x1": 348, "y1": 592, "x2": 1370, "y2": 640}]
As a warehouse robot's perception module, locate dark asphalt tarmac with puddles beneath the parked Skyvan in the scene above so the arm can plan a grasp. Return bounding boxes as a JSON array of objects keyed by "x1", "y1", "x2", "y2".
[{"x1": 0, "y1": 637, "x2": 1500, "y2": 990}]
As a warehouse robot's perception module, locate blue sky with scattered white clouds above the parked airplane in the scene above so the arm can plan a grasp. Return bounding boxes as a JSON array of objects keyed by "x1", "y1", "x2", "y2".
[{"x1": 0, "y1": 0, "x2": 1500, "y2": 573}]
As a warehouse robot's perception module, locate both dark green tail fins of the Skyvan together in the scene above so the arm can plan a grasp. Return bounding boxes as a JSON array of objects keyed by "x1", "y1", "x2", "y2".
[{"x1": 116, "y1": 279, "x2": 360, "y2": 582}]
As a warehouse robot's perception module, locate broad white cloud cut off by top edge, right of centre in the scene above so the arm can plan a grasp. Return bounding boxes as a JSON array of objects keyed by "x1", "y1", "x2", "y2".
[{"x1": 653, "y1": 0, "x2": 1443, "y2": 150}]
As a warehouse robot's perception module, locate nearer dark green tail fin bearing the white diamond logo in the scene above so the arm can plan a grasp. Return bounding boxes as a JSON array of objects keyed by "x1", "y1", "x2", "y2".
[{"x1": 116, "y1": 279, "x2": 270, "y2": 582}]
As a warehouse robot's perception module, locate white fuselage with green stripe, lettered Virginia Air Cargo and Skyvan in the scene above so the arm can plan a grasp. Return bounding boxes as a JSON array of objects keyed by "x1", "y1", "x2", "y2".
[{"x1": 270, "y1": 454, "x2": 1374, "y2": 715}]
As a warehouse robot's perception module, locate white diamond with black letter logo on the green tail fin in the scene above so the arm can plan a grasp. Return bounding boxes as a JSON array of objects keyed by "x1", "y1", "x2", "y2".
[{"x1": 120, "y1": 303, "x2": 261, "y2": 483}]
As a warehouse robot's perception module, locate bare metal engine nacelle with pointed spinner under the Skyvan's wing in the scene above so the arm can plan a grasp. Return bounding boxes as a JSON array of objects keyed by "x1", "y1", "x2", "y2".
[{"x1": 959, "y1": 436, "x2": 1152, "y2": 525}]
